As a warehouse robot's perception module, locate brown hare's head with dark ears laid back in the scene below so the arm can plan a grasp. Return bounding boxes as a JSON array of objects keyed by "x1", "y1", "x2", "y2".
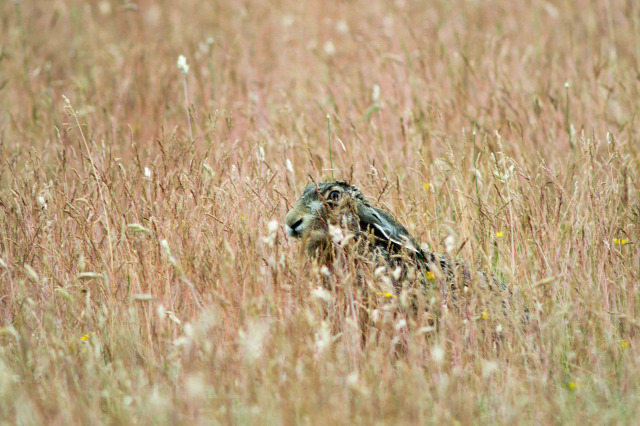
[{"x1": 285, "y1": 181, "x2": 423, "y2": 258}]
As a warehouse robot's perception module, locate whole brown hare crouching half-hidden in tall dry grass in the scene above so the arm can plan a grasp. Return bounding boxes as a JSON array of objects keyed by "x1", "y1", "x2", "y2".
[{"x1": 285, "y1": 181, "x2": 531, "y2": 340}]
